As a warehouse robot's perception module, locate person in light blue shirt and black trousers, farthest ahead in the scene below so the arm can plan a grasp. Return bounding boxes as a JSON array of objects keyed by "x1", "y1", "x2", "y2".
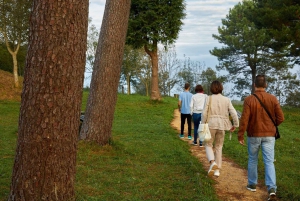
[{"x1": 178, "y1": 83, "x2": 193, "y2": 140}]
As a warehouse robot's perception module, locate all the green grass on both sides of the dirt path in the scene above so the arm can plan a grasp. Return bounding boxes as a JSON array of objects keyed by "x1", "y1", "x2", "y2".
[{"x1": 0, "y1": 92, "x2": 300, "y2": 201}]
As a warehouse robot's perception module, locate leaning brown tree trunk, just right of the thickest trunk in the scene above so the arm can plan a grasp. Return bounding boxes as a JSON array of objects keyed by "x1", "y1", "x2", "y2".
[{"x1": 80, "y1": 0, "x2": 131, "y2": 145}]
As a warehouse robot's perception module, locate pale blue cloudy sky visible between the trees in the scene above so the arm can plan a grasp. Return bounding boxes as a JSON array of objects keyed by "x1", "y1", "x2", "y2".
[{"x1": 85, "y1": 0, "x2": 240, "y2": 86}]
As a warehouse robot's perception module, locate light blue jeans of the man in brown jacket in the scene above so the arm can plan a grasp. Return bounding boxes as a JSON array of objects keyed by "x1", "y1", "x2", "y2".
[{"x1": 247, "y1": 137, "x2": 277, "y2": 191}]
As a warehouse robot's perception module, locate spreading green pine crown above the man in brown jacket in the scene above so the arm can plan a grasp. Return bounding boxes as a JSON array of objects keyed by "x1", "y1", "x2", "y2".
[{"x1": 210, "y1": 1, "x2": 292, "y2": 97}]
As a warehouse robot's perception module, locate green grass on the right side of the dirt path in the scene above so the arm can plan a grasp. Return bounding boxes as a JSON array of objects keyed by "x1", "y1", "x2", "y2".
[{"x1": 223, "y1": 106, "x2": 300, "y2": 200}]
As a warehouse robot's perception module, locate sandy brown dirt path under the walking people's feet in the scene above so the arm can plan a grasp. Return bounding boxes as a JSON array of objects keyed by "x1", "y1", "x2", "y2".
[{"x1": 171, "y1": 110, "x2": 268, "y2": 201}]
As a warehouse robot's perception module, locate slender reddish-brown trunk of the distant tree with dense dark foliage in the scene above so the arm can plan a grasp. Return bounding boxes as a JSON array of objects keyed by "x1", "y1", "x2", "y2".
[{"x1": 145, "y1": 45, "x2": 161, "y2": 100}]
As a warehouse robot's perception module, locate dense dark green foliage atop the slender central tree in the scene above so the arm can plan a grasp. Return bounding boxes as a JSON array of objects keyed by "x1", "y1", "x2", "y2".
[{"x1": 127, "y1": 0, "x2": 185, "y2": 50}]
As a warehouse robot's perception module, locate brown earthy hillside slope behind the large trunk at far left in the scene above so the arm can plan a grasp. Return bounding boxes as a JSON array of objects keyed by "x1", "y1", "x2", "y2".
[{"x1": 0, "y1": 70, "x2": 23, "y2": 101}]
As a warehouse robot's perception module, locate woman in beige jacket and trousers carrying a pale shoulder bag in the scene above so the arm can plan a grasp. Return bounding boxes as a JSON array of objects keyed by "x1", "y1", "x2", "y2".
[{"x1": 202, "y1": 80, "x2": 239, "y2": 177}]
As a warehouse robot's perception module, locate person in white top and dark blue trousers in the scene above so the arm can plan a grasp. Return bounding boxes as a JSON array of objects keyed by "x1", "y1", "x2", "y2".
[{"x1": 190, "y1": 85, "x2": 207, "y2": 147}]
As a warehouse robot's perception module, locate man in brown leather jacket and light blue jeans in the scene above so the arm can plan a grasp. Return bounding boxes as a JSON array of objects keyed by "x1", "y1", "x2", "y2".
[{"x1": 238, "y1": 75, "x2": 284, "y2": 200}]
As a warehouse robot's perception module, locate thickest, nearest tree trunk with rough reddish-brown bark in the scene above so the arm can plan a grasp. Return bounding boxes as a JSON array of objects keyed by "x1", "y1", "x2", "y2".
[{"x1": 8, "y1": 0, "x2": 89, "y2": 201}]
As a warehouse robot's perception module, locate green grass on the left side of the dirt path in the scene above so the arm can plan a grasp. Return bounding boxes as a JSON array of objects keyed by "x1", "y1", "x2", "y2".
[{"x1": 0, "y1": 92, "x2": 218, "y2": 201}]
